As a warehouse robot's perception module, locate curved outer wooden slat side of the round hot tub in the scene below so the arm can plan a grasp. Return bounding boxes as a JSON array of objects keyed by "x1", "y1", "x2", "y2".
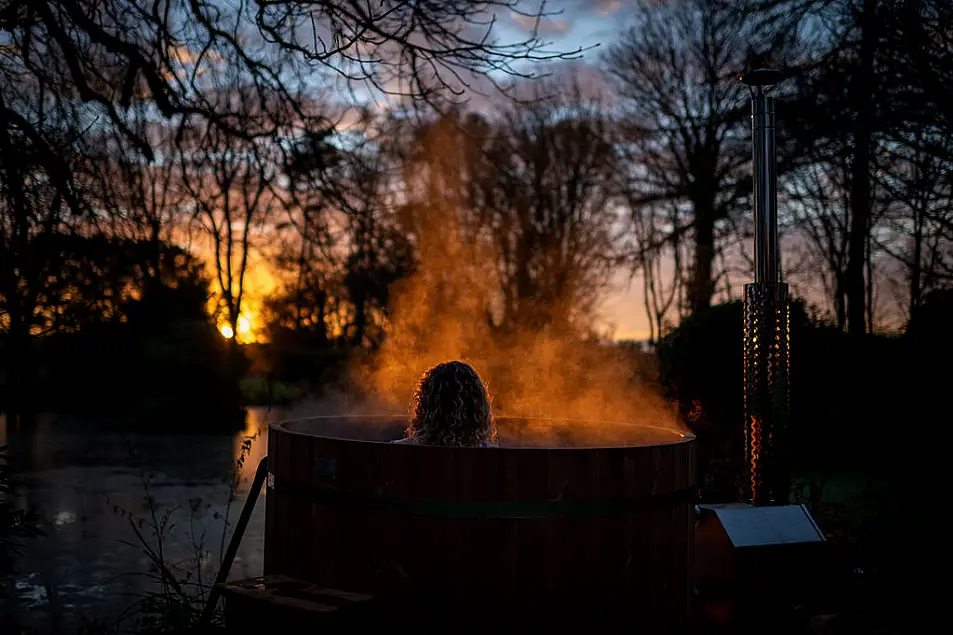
[{"x1": 265, "y1": 420, "x2": 695, "y2": 622}]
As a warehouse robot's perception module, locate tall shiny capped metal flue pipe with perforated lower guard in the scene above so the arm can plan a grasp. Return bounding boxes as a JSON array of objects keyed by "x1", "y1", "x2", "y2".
[{"x1": 740, "y1": 69, "x2": 790, "y2": 505}]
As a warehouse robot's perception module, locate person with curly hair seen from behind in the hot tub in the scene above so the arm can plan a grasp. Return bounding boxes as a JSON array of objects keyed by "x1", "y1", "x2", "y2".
[{"x1": 394, "y1": 361, "x2": 498, "y2": 448}]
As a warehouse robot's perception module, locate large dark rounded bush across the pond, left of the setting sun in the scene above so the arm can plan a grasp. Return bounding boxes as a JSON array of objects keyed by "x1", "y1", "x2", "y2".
[{"x1": 0, "y1": 236, "x2": 241, "y2": 427}]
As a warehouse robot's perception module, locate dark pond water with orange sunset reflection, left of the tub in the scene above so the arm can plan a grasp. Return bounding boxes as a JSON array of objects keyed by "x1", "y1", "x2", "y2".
[{"x1": 0, "y1": 409, "x2": 280, "y2": 621}]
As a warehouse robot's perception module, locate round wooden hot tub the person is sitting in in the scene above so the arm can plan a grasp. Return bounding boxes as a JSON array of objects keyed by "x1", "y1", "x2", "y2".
[{"x1": 264, "y1": 417, "x2": 695, "y2": 632}]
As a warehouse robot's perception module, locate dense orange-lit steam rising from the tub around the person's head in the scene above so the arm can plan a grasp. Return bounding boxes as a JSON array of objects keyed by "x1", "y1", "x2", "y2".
[{"x1": 355, "y1": 196, "x2": 681, "y2": 443}]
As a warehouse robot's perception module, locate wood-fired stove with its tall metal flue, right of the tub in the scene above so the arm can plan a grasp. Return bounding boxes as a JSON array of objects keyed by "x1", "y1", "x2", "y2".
[{"x1": 695, "y1": 69, "x2": 825, "y2": 632}]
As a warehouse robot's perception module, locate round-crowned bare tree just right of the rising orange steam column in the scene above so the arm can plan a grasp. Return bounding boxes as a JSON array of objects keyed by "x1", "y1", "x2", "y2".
[{"x1": 474, "y1": 79, "x2": 620, "y2": 332}]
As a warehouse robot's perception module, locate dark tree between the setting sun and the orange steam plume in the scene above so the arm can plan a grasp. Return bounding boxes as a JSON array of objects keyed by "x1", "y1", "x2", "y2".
[{"x1": 273, "y1": 111, "x2": 411, "y2": 346}]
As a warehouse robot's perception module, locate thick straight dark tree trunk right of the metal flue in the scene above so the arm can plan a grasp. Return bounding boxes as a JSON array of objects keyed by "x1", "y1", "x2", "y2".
[{"x1": 846, "y1": 0, "x2": 877, "y2": 336}]
